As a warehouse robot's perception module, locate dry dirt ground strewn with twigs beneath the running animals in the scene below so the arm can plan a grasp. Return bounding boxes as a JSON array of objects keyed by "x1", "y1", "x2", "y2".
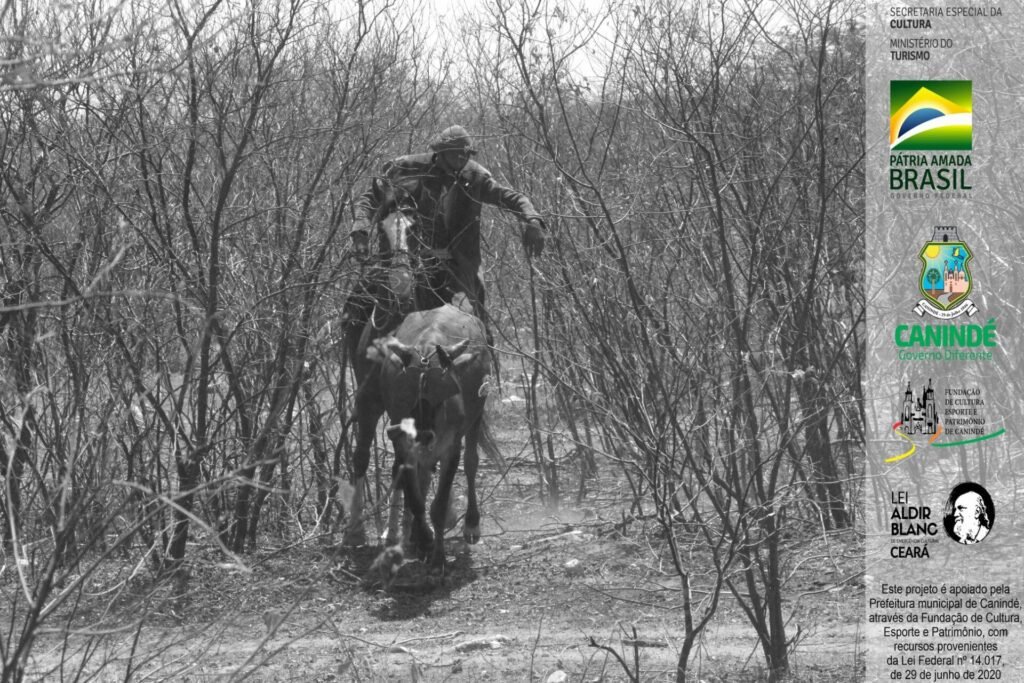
[{"x1": 14, "y1": 403, "x2": 864, "y2": 683}]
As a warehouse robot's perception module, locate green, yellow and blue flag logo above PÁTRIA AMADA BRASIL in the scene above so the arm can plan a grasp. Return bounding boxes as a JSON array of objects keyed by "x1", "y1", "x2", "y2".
[{"x1": 889, "y1": 81, "x2": 973, "y2": 152}]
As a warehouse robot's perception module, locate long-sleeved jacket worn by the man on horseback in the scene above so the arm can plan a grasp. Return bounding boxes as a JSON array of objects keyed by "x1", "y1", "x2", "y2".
[{"x1": 355, "y1": 153, "x2": 543, "y2": 275}]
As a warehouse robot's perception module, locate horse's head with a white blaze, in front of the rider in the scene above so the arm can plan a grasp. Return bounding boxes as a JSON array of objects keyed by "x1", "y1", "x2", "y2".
[{"x1": 373, "y1": 179, "x2": 416, "y2": 303}]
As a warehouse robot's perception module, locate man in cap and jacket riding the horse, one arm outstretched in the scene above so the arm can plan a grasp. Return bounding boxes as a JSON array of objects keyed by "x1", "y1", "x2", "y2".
[{"x1": 344, "y1": 126, "x2": 547, "y2": 348}]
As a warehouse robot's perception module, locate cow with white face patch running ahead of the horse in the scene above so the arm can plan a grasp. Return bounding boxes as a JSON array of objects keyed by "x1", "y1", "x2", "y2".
[{"x1": 345, "y1": 297, "x2": 492, "y2": 568}]
